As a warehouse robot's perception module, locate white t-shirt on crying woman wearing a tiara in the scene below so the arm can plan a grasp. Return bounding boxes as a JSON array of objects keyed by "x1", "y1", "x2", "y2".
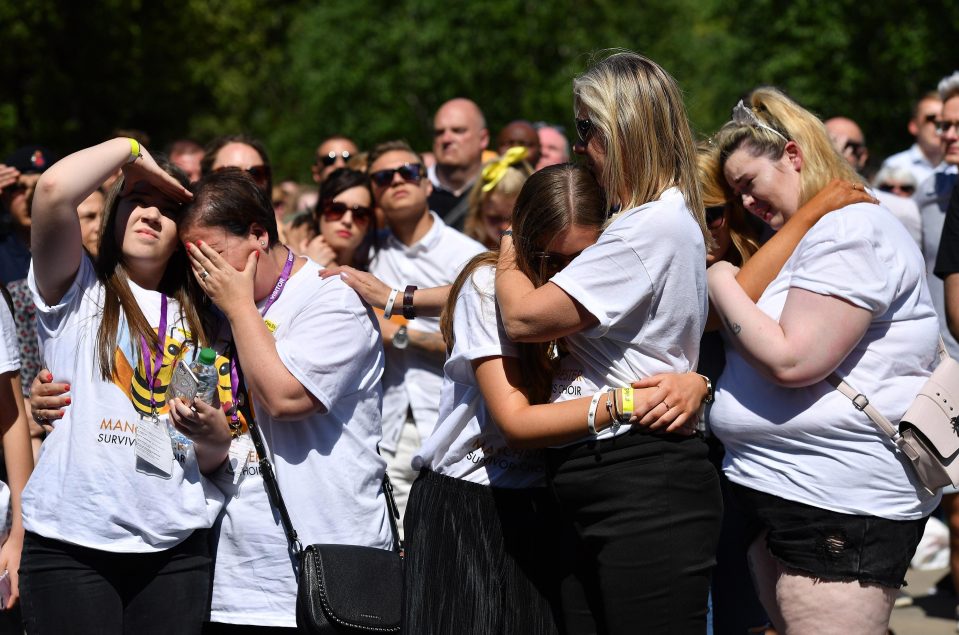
[{"x1": 710, "y1": 204, "x2": 939, "y2": 520}]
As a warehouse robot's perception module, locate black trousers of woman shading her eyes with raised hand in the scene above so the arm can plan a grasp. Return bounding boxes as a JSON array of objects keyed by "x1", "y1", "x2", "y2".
[{"x1": 20, "y1": 530, "x2": 211, "y2": 635}]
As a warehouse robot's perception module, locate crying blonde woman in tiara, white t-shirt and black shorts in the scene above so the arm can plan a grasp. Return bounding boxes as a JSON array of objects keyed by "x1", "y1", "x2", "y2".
[{"x1": 708, "y1": 88, "x2": 939, "y2": 635}]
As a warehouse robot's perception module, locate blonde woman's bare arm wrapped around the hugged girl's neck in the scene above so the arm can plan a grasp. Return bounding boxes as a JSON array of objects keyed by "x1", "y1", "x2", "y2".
[{"x1": 496, "y1": 235, "x2": 598, "y2": 342}]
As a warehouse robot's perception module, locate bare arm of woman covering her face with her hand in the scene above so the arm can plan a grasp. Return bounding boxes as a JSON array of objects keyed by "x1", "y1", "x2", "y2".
[{"x1": 187, "y1": 244, "x2": 327, "y2": 419}]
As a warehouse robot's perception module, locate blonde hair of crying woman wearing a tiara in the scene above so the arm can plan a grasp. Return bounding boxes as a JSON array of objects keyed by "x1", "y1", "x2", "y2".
[{"x1": 713, "y1": 86, "x2": 863, "y2": 206}]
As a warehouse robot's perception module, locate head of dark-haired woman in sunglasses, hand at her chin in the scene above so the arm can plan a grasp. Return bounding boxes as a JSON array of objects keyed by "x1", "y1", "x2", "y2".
[{"x1": 302, "y1": 168, "x2": 376, "y2": 270}]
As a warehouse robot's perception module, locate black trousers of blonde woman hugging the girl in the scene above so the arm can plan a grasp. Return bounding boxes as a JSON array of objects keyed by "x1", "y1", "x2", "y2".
[{"x1": 547, "y1": 430, "x2": 722, "y2": 635}]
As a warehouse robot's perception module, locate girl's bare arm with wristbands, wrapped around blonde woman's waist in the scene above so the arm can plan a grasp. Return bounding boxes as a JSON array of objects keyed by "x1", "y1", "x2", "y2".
[{"x1": 473, "y1": 357, "x2": 706, "y2": 449}]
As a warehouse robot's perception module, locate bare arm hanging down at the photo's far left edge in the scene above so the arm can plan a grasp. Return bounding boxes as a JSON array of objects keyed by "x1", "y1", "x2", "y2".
[{"x1": 0, "y1": 371, "x2": 33, "y2": 609}]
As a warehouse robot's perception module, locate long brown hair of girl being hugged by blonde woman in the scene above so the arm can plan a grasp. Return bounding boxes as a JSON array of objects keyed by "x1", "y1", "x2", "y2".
[{"x1": 440, "y1": 163, "x2": 606, "y2": 403}]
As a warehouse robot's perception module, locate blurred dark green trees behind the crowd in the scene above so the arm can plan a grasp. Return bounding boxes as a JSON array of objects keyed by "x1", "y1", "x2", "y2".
[{"x1": 0, "y1": 0, "x2": 959, "y2": 181}]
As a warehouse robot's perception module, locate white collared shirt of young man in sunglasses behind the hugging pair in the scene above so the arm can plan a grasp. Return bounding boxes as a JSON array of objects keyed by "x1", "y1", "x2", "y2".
[{"x1": 370, "y1": 212, "x2": 485, "y2": 452}]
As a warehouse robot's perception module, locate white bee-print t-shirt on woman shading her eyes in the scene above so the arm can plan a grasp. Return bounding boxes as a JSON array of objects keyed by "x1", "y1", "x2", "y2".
[{"x1": 23, "y1": 256, "x2": 223, "y2": 553}]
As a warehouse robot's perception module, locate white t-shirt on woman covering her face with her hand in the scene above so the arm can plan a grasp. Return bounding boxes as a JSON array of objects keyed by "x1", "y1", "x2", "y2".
[{"x1": 210, "y1": 261, "x2": 392, "y2": 626}]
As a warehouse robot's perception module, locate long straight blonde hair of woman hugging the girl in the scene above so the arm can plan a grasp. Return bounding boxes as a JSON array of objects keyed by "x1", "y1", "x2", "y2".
[{"x1": 573, "y1": 50, "x2": 711, "y2": 245}]
